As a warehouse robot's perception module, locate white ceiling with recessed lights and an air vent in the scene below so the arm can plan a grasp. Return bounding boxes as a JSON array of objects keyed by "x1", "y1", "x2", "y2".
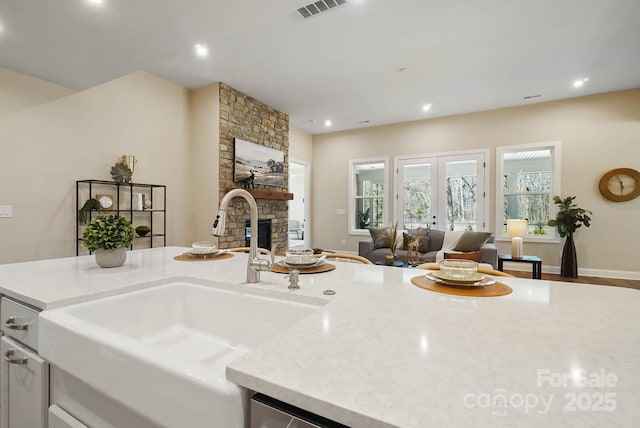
[{"x1": 0, "y1": 0, "x2": 640, "y2": 134}]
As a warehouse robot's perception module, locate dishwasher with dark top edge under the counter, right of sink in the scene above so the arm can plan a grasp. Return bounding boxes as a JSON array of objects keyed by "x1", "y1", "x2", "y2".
[{"x1": 251, "y1": 393, "x2": 349, "y2": 428}]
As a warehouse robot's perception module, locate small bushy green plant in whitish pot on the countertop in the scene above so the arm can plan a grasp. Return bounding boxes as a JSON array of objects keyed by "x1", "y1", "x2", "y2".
[{"x1": 82, "y1": 214, "x2": 135, "y2": 268}]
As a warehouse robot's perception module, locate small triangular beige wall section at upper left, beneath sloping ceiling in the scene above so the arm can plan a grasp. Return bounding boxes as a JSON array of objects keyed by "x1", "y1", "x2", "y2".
[{"x1": 0, "y1": 67, "x2": 75, "y2": 117}]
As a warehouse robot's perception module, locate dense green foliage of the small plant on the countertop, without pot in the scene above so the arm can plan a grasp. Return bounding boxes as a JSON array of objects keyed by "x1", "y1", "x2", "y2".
[{"x1": 82, "y1": 214, "x2": 135, "y2": 251}]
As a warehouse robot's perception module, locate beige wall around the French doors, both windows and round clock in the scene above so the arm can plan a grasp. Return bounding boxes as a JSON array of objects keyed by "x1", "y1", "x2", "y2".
[{"x1": 312, "y1": 90, "x2": 640, "y2": 277}]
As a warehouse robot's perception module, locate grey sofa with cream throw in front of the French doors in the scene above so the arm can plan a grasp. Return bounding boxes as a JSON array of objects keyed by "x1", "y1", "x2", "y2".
[{"x1": 358, "y1": 229, "x2": 498, "y2": 269}]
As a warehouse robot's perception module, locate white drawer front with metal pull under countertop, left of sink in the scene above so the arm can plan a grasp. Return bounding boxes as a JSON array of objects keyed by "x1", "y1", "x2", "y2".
[{"x1": 0, "y1": 297, "x2": 39, "y2": 350}]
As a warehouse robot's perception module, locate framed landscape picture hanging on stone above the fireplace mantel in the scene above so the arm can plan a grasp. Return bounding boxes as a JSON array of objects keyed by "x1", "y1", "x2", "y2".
[{"x1": 233, "y1": 138, "x2": 284, "y2": 187}]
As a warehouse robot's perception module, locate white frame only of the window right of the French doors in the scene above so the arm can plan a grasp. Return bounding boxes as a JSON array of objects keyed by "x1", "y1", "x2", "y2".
[{"x1": 495, "y1": 141, "x2": 562, "y2": 243}]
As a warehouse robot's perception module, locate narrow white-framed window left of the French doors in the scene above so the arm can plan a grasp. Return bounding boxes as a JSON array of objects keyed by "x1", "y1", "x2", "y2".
[{"x1": 349, "y1": 158, "x2": 388, "y2": 234}]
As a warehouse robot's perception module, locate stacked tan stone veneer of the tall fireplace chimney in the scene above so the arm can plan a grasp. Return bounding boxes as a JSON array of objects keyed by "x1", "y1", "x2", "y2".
[{"x1": 218, "y1": 83, "x2": 289, "y2": 252}]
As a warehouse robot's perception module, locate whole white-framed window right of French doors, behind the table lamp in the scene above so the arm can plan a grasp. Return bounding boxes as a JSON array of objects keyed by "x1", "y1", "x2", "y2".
[{"x1": 496, "y1": 142, "x2": 560, "y2": 241}]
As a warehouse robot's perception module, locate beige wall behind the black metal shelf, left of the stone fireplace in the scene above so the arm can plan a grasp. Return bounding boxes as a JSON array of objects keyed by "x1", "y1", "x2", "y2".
[{"x1": 0, "y1": 72, "x2": 192, "y2": 263}]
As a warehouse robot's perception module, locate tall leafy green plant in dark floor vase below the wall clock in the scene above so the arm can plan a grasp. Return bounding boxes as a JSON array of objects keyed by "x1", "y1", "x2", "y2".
[{"x1": 549, "y1": 196, "x2": 593, "y2": 278}]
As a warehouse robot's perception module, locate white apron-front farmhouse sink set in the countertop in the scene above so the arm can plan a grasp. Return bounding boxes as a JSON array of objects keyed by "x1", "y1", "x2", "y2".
[{"x1": 38, "y1": 278, "x2": 326, "y2": 428}]
